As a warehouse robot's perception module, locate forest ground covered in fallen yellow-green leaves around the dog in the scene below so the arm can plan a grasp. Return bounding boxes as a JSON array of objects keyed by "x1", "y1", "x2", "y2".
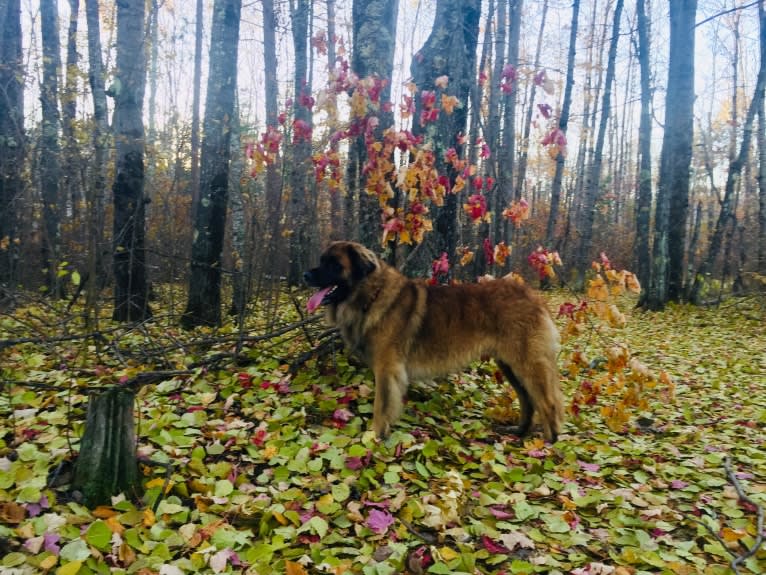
[{"x1": 0, "y1": 293, "x2": 766, "y2": 575}]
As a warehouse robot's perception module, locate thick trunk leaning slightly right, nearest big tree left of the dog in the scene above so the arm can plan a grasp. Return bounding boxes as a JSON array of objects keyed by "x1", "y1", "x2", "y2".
[{"x1": 181, "y1": 0, "x2": 242, "y2": 329}]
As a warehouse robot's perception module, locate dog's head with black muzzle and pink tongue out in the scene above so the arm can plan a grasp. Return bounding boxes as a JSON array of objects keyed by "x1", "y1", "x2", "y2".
[{"x1": 303, "y1": 242, "x2": 380, "y2": 312}]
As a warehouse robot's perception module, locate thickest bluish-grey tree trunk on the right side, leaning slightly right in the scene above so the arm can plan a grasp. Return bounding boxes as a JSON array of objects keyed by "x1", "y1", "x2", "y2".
[{"x1": 641, "y1": 0, "x2": 697, "y2": 310}]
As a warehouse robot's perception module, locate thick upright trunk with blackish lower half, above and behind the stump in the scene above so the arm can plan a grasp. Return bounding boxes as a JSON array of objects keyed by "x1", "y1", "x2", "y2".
[{"x1": 108, "y1": 0, "x2": 151, "y2": 321}]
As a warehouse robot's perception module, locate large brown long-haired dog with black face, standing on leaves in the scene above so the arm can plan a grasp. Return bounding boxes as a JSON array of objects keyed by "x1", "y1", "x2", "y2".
[{"x1": 305, "y1": 242, "x2": 564, "y2": 441}]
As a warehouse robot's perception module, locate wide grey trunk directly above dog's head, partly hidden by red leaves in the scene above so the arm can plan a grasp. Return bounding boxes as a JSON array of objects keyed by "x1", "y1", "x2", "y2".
[{"x1": 350, "y1": 0, "x2": 399, "y2": 248}]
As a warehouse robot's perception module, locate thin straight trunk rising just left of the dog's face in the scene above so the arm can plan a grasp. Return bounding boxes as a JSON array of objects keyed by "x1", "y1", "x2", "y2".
[{"x1": 287, "y1": 0, "x2": 312, "y2": 286}]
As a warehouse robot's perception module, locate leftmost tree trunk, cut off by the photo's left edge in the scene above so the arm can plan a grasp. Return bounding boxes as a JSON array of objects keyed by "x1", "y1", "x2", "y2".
[{"x1": 0, "y1": 0, "x2": 25, "y2": 290}]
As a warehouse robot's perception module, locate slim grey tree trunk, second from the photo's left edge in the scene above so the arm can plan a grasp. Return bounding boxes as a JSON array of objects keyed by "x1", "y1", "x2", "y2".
[{"x1": 40, "y1": 0, "x2": 62, "y2": 298}]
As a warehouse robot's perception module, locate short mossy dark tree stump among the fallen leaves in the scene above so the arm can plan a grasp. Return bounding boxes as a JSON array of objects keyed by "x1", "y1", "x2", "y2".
[{"x1": 73, "y1": 387, "x2": 140, "y2": 508}]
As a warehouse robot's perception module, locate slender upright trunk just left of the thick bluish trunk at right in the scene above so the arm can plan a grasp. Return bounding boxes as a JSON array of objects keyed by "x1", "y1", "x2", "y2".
[{"x1": 635, "y1": 0, "x2": 652, "y2": 300}]
